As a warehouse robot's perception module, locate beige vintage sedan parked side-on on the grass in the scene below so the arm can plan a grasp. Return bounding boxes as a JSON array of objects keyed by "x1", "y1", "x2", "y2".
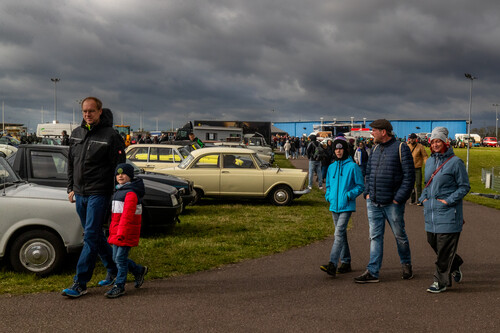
[{"x1": 154, "y1": 147, "x2": 310, "y2": 206}]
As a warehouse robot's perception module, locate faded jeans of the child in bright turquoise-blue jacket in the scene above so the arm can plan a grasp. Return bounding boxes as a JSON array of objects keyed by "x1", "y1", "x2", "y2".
[{"x1": 330, "y1": 212, "x2": 352, "y2": 267}]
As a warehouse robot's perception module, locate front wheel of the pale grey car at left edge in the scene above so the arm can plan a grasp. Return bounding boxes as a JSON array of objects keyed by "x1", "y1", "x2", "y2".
[{"x1": 10, "y1": 230, "x2": 66, "y2": 276}]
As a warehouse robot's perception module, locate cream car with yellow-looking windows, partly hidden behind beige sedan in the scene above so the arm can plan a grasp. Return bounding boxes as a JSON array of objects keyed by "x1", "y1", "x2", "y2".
[{"x1": 126, "y1": 143, "x2": 189, "y2": 171}]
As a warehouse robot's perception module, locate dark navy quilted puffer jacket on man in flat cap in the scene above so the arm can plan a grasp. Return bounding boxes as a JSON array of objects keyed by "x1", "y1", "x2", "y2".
[{"x1": 364, "y1": 138, "x2": 415, "y2": 205}]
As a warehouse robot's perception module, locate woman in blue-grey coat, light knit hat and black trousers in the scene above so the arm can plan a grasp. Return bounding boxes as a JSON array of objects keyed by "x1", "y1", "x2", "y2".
[{"x1": 419, "y1": 127, "x2": 470, "y2": 293}]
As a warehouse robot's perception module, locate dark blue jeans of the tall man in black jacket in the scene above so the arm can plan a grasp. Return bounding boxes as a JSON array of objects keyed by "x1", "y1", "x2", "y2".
[{"x1": 74, "y1": 195, "x2": 117, "y2": 286}]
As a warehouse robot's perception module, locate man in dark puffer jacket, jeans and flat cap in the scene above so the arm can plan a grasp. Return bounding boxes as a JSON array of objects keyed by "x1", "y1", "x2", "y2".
[{"x1": 354, "y1": 119, "x2": 415, "y2": 283}]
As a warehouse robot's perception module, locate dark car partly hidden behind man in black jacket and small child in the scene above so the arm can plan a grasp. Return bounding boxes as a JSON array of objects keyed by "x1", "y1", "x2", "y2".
[{"x1": 7, "y1": 144, "x2": 184, "y2": 230}]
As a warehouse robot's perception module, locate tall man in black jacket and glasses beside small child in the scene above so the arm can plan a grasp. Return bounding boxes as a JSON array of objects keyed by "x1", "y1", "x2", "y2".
[{"x1": 62, "y1": 97, "x2": 125, "y2": 298}]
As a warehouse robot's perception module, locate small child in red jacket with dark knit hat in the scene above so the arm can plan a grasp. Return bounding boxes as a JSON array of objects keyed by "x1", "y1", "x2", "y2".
[{"x1": 104, "y1": 163, "x2": 148, "y2": 298}]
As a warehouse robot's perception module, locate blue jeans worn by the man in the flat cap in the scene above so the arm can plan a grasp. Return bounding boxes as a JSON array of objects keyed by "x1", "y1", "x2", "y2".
[{"x1": 366, "y1": 199, "x2": 411, "y2": 278}]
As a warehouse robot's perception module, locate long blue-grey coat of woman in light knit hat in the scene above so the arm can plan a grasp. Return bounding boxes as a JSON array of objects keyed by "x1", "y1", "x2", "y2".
[{"x1": 420, "y1": 147, "x2": 470, "y2": 233}]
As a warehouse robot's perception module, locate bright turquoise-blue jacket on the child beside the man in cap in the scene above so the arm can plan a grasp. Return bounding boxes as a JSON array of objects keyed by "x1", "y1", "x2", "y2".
[{"x1": 325, "y1": 156, "x2": 364, "y2": 213}]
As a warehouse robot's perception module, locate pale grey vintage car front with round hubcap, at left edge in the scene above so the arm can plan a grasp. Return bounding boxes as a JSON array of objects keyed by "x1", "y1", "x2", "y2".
[{"x1": 0, "y1": 157, "x2": 83, "y2": 276}]
